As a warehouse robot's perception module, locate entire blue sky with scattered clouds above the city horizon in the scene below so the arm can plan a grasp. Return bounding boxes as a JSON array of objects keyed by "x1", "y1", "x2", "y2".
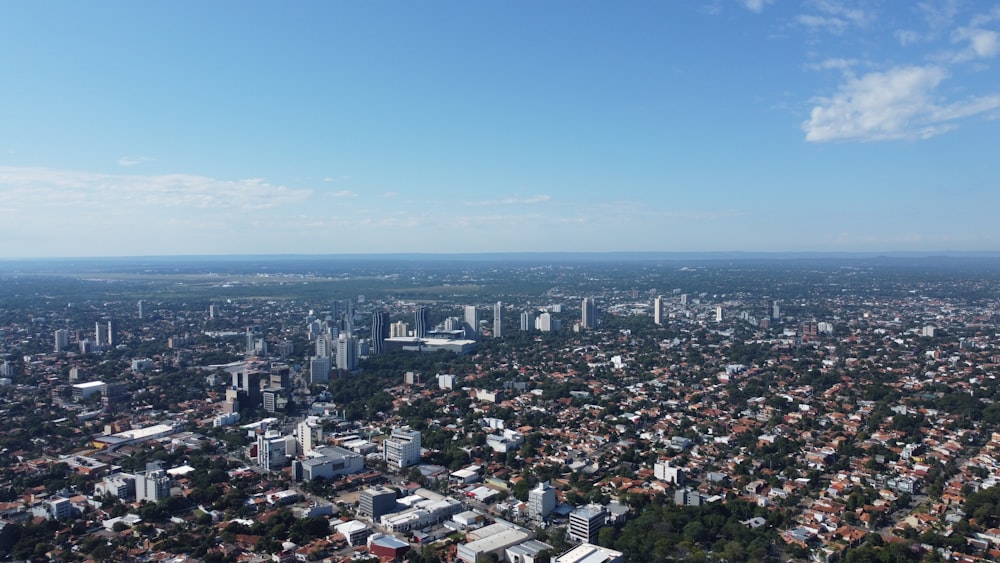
[{"x1": 0, "y1": 0, "x2": 1000, "y2": 257}]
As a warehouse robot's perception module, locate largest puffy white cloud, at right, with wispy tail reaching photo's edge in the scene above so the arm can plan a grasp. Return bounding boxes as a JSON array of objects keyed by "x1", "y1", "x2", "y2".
[{"x1": 802, "y1": 65, "x2": 1000, "y2": 142}]
